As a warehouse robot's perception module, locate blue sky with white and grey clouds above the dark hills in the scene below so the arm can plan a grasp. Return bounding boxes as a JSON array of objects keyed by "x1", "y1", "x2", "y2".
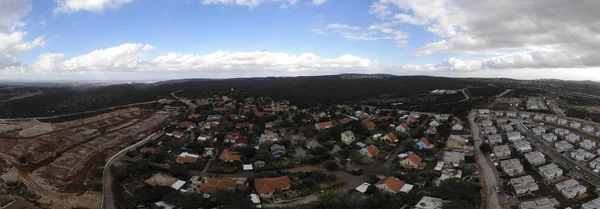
[{"x1": 0, "y1": 0, "x2": 600, "y2": 81}]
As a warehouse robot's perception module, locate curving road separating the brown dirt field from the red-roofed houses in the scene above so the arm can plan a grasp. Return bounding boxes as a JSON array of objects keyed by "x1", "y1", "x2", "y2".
[{"x1": 100, "y1": 131, "x2": 165, "y2": 209}]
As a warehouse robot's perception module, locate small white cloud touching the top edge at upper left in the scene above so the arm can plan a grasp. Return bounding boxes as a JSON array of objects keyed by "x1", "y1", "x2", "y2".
[{"x1": 53, "y1": 0, "x2": 134, "y2": 15}]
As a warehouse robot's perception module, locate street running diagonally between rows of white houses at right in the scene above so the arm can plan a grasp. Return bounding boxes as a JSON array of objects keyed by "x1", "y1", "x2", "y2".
[{"x1": 511, "y1": 119, "x2": 600, "y2": 187}]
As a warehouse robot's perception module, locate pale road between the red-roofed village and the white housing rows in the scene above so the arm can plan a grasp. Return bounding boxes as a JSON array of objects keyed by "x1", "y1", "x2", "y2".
[{"x1": 469, "y1": 112, "x2": 504, "y2": 209}]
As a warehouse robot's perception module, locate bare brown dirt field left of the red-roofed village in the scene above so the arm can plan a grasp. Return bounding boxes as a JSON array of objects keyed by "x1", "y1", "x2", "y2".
[{"x1": 0, "y1": 108, "x2": 170, "y2": 209}]
